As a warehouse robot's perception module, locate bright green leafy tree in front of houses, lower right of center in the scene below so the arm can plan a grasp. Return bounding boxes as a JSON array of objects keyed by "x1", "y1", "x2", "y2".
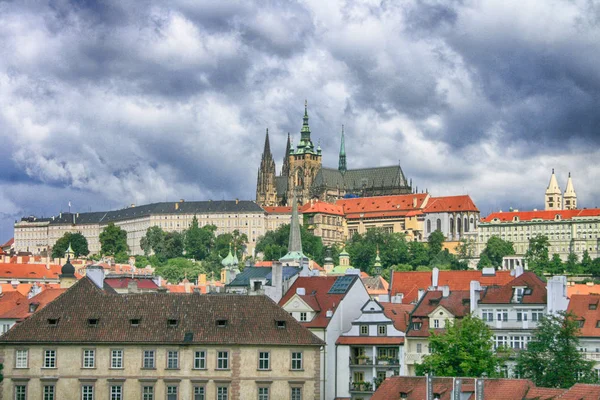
[{"x1": 416, "y1": 315, "x2": 503, "y2": 377}]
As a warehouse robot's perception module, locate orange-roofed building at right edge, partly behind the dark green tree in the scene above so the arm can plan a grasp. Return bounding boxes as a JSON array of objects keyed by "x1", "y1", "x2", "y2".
[{"x1": 567, "y1": 293, "x2": 600, "y2": 378}]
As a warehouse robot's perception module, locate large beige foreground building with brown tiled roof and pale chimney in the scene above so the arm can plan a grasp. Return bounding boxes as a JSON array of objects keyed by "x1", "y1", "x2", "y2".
[{"x1": 0, "y1": 267, "x2": 324, "y2": 400}]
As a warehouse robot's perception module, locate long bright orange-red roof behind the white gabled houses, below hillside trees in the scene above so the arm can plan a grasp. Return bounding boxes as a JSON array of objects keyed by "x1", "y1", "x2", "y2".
[{"x1": 390, "y1": 271, "x2": 514, "y2": 303}]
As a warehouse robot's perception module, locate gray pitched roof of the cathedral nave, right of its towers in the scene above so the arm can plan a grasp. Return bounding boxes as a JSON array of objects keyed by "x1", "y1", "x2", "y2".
[{"x1": 313, "y1": 165, "x2": 409, "y2": 191}]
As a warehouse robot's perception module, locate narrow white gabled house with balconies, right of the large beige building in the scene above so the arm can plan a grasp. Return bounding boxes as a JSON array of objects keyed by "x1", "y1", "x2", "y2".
[{"x1": 336, "y1": 299, "x2": 413, "y2": 400}]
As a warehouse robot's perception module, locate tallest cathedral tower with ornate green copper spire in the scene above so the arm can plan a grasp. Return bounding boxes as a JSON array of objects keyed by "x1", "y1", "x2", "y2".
[{"x1": 287, "y1": 101, "x2": 321, "y2": 204}]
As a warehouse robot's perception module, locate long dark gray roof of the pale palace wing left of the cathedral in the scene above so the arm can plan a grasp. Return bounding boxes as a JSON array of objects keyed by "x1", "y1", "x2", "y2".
[{"x1": 25, "y1": 200, "x2": 264, "y2": 225}]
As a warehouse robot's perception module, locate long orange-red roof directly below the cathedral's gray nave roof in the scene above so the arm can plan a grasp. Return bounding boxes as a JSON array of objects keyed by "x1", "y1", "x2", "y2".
[{"x1": 335, "y1": 193, "x2": 429, "y2": 219}]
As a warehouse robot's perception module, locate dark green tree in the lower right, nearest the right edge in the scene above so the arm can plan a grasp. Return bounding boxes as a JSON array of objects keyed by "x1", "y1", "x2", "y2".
[{"x1": 516, "y1": 313, "x2": 594, "y2": 388}]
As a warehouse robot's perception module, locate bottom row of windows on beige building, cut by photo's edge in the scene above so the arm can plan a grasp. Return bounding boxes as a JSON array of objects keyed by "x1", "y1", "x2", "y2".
[{"x1": 14, "y1": 384, "x2": 302, "y2": 400}]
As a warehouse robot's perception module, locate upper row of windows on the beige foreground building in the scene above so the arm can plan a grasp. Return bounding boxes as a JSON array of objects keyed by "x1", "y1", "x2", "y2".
[{"x1": 15, "y1": 349, "x2": 302, "y2": 371}]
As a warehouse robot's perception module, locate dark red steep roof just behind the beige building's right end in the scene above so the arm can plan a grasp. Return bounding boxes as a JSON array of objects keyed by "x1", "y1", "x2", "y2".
[{"x1": 279, "y1": 276, "x2": 362, "y2": 328}]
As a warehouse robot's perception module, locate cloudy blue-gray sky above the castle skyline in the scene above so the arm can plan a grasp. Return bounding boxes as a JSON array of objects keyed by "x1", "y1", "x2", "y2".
[{"x1": 0, "y1": 0, "x2": 600, "y2": 241}]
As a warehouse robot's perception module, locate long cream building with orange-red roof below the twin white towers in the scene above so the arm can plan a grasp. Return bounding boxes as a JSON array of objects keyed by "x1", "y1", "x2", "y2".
[{"x1": 476, "y1": 208, "x2": 600, "y2": 261}]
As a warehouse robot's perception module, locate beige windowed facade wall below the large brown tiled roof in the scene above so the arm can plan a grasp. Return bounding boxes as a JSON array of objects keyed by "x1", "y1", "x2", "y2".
[{"x1": 0, "y1": 345, "x2": 320, "y2": 399}]
